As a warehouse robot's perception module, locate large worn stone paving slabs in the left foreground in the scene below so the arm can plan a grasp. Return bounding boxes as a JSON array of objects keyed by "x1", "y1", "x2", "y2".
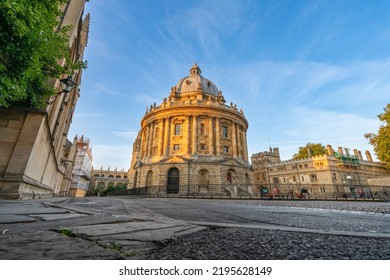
[{"x1": 0, "y1": 198, "x2": 205, "y2": 260}]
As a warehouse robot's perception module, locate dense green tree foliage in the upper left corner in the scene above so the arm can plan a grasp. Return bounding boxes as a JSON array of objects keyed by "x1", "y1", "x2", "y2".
[{"x1": 0, "y1": 0, "x2": 72, "y2": 107}]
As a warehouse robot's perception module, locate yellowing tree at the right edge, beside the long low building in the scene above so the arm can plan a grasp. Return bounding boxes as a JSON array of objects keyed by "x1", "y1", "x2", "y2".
[{"x1": 364, "y1": 103, "x2": 390, "y2": 170}]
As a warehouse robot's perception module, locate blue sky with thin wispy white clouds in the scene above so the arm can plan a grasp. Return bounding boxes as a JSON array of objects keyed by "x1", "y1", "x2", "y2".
[{"x1": 69, "y1": 0, "x2": 390, "y2": 170}]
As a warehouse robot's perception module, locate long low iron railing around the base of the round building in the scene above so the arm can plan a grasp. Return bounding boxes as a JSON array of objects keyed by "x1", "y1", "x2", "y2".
[{"x1": 107, "y1": 184, "x2": 390, "y2": 201}]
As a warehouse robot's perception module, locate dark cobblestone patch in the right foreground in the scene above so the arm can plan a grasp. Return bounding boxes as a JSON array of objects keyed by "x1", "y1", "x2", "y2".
[{"x1": 140, "y1": 228, "x2": 390, "y2": 260}]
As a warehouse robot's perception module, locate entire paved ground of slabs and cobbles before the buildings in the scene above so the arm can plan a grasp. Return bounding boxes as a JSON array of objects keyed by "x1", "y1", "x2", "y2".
[{"x1": 0, "y1": 197, "x2": 390, "y2": 260}]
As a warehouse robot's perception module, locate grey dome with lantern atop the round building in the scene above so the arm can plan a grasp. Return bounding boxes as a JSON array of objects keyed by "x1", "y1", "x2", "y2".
[{"x1": 176, "y1": 63, "x2": 218, "y2": 96}]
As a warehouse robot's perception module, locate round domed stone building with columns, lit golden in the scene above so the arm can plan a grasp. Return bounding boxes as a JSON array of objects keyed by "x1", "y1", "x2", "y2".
[{"x1": 129, "y1": 64, "x2": 253, "y2": 195}]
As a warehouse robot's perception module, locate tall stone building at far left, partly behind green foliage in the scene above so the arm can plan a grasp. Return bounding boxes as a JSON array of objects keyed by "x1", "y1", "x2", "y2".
[{"x1": 0, "y1": 0, "x2": 89, "y2": 199}]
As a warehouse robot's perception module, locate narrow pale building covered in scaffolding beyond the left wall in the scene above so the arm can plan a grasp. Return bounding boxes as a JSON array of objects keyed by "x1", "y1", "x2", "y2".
[{"x1": 69, "y1": 136, "x2": 92, "y2": 197}]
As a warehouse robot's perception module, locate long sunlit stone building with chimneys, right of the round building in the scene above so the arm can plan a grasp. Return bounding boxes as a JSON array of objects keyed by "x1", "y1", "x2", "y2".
[{"x1": 251, "y1": 145, "x2": 390, "y2": 197}]
